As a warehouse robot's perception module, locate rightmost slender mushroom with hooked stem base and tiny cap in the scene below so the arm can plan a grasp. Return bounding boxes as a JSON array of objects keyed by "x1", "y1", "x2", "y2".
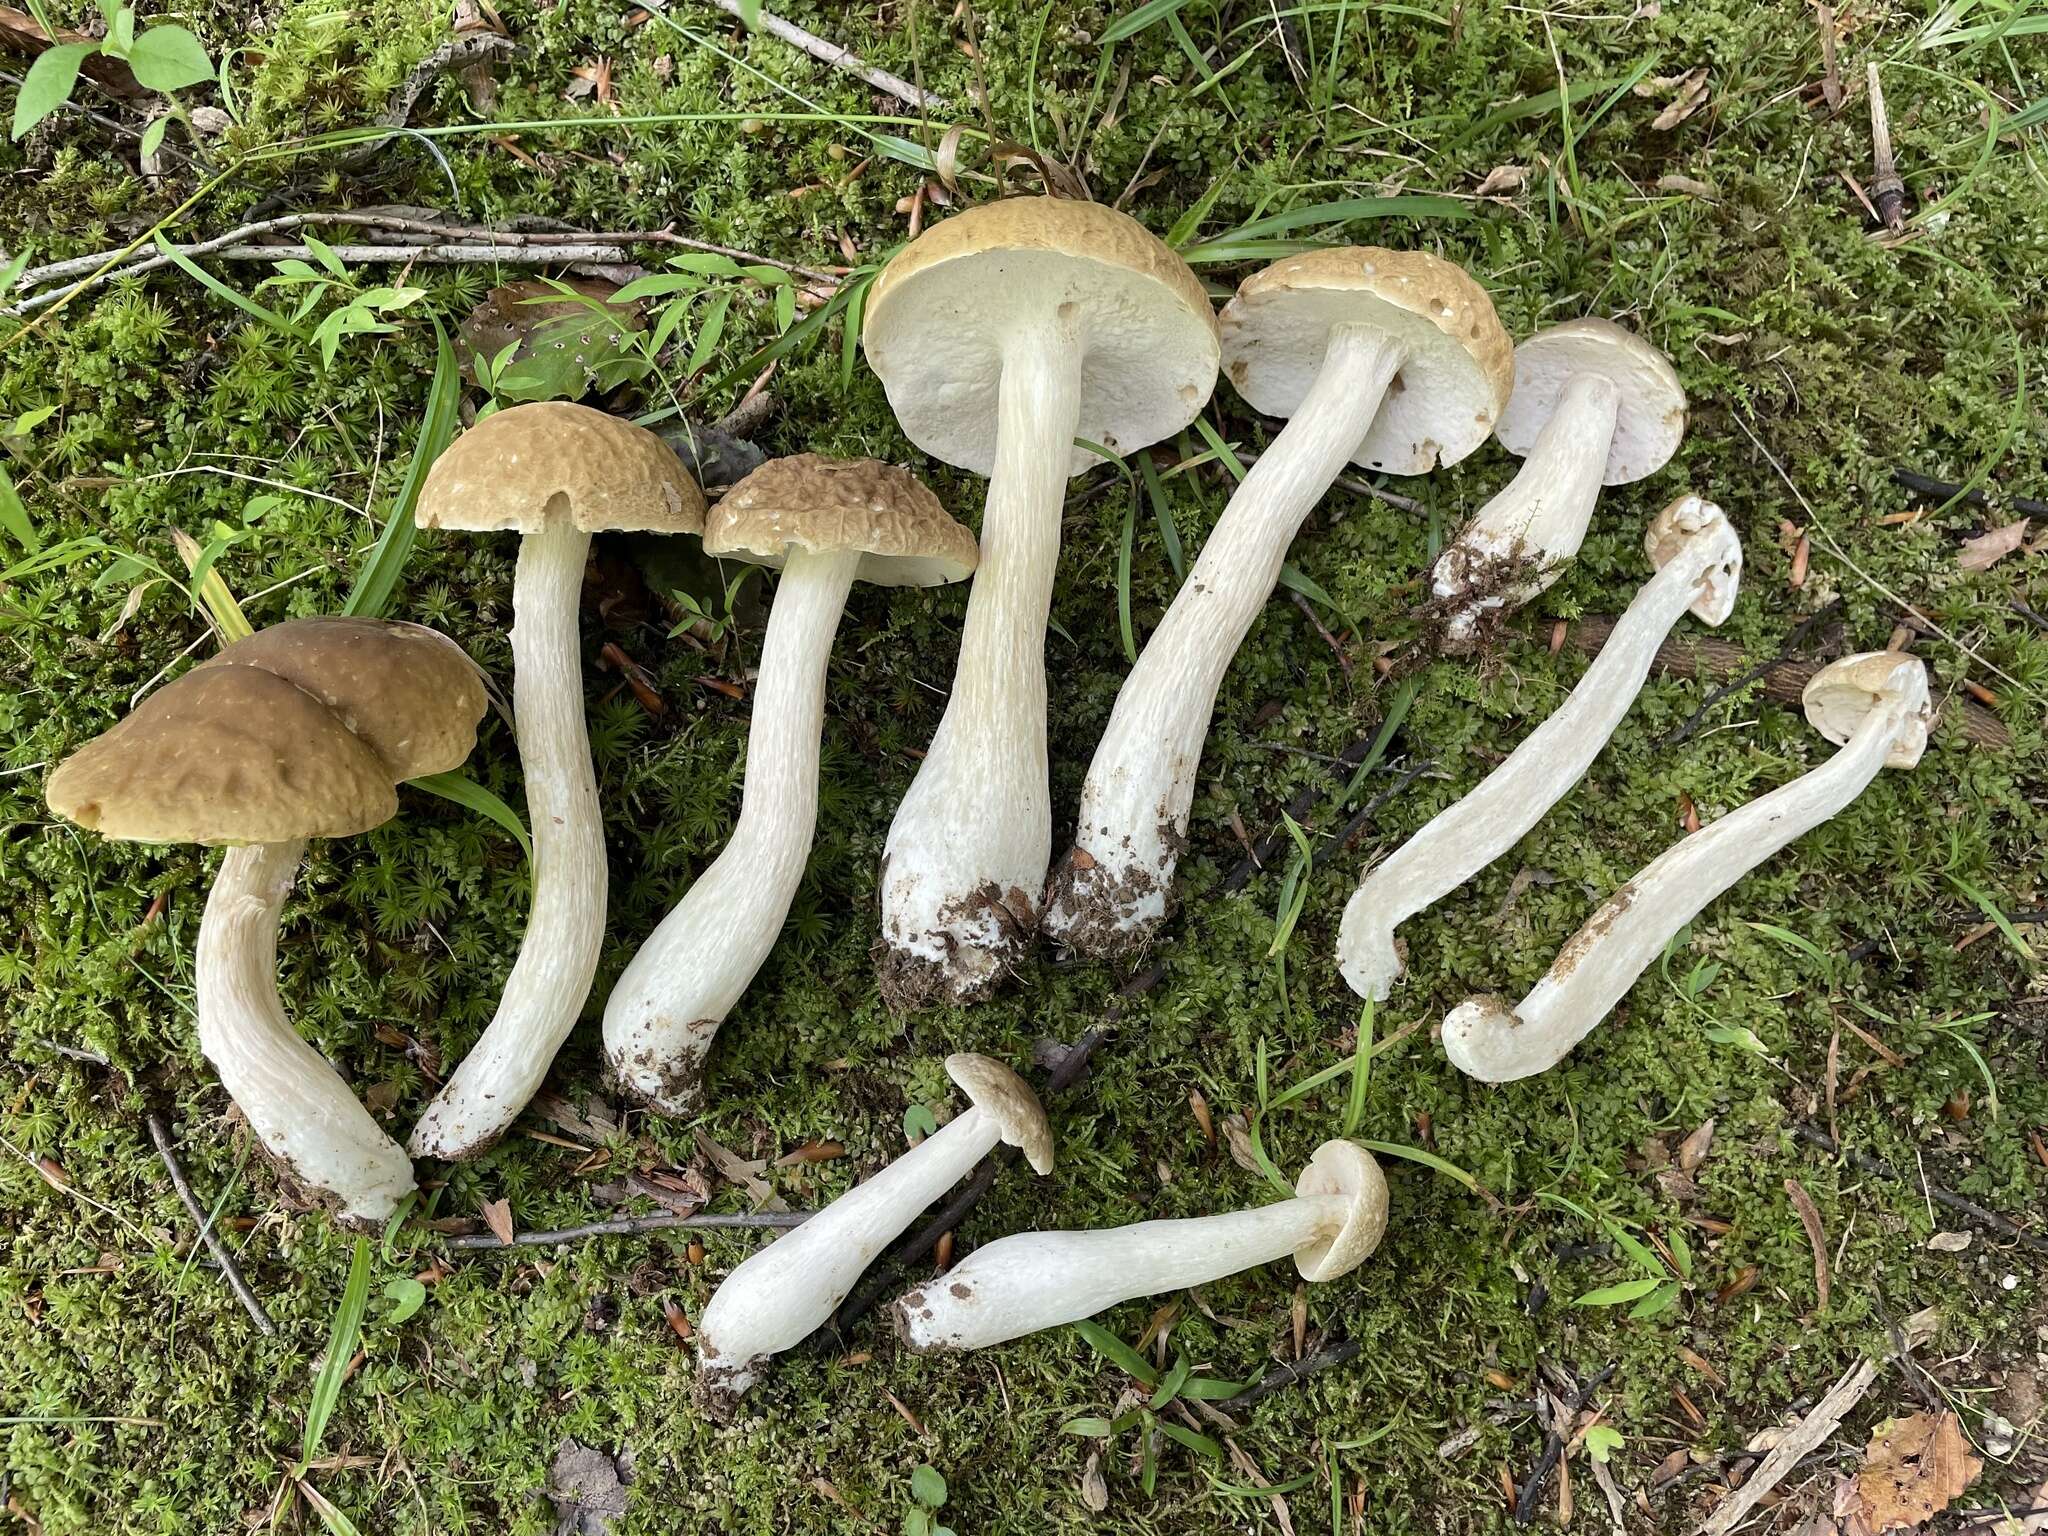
[{"x1": 1444, "y1": 651, "x2": 1933, "y2": 1083}]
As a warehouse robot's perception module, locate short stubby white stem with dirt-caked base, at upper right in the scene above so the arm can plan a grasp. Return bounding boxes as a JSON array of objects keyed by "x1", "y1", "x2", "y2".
[{"x1": 1432, "y1": 373, "x2": 1622, "y2": 641}]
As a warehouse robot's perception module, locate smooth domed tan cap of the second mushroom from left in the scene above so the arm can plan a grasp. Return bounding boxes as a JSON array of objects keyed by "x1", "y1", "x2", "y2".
[{"x1": 414, "y1": 399, "x2": 705, "y2": 532}]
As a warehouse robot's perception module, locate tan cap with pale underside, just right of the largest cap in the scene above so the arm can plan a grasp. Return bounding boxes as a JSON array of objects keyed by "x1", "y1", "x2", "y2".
[{"x1": 1223, "y1": 246, "x2": 1516, "y2": 475}]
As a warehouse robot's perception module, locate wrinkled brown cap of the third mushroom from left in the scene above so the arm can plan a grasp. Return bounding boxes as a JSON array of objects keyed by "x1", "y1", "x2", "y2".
[{"x1": 705, "y1": 453, "x2": 981, "y2": 586}]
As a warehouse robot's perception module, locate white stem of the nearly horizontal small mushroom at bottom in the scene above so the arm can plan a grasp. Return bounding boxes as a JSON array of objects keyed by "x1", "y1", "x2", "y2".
[{"x1": 895, "y1": 1194, "x2": 1352, "y2": 1350}]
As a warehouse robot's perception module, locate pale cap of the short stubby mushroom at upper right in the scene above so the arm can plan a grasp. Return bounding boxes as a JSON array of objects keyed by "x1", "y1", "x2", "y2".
[{"x1": 1497, "y1": 319, "x2": 1686, "y2": 485}]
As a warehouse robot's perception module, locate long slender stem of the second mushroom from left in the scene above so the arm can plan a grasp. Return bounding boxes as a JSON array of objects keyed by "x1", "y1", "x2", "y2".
[{"x1": 412, "y1": 516, "x2": 604, "y2": 1161}]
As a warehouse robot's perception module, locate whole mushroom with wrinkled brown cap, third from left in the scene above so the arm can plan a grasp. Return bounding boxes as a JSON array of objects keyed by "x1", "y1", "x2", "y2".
[{"x1": 604, "y1": 453, "x2": 975, "y2": 1114}]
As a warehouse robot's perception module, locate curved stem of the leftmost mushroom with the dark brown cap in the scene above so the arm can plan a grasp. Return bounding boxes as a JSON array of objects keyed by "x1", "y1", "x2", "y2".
[{"x1": 195, "y1": 840, "x2": 414, "y2": 1227}]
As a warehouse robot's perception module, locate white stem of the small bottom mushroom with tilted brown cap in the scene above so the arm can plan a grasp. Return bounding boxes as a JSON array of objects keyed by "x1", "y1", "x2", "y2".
[{"x1": 696, "y1": 1108, "x2": 997, "y2": 1393}]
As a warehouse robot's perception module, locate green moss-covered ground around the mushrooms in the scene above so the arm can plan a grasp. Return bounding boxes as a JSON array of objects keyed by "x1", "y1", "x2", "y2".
[{"x1": 0, "y1": 0, "x2": 2048, "y2": 1534}]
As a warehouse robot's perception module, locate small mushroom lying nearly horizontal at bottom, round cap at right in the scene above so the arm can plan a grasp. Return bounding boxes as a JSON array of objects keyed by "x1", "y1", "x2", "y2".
[{"x1": 895, "y1": 1141, "x2": 1386, "y2": 1354}]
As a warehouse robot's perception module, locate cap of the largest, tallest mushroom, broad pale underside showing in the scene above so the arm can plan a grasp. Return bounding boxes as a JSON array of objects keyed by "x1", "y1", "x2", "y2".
[{"x1": 860, "y1": 197, "x2": 1217, "y2": 475}]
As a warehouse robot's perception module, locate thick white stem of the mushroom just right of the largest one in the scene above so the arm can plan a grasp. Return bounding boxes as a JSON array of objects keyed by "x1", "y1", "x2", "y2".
[{"x1": 1044, "y1": 326, "x2": 1407, "y2": 954}]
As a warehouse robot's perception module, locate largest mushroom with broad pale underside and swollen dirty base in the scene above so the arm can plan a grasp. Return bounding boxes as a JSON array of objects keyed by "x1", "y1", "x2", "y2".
[{"x1": 860, "y1": 197, "x2": 1217, "y2": 1010}]
